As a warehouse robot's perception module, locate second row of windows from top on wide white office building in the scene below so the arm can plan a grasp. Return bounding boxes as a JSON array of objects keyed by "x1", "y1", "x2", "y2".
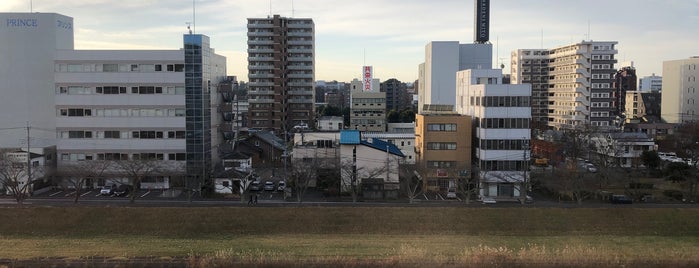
[{"x1": 56, "y1": 86, "x2": 185, "y2": 95}]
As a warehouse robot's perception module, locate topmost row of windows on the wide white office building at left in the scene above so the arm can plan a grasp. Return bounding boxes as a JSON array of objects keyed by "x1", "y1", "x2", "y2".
[{"x1": 55, "y1": 63, "x2": 184, "y2": 73}]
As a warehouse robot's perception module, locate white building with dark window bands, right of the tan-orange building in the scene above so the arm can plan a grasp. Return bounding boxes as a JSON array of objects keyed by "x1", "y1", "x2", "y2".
[{"x1": 456, "y1": 69, "x2": 531, "y2": 200}]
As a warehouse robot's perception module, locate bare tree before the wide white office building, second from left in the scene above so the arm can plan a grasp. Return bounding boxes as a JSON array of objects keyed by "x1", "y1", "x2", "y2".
[{"x1": 58, "y1": 160, "x2": 111, "y2": 204}]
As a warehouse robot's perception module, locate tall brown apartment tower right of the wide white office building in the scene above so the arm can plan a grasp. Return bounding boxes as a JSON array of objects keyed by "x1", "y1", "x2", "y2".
[{"x1": 247, "y1": 15, "x2": 315, "y2": 134}]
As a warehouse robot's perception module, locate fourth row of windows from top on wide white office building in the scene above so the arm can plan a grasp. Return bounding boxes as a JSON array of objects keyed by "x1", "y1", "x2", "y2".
[{"x1": 57, "y1": 130, "x2": 185, "y2": 139}]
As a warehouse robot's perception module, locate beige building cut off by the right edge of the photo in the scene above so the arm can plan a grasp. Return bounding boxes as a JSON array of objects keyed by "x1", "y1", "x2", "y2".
[{"x1": 661, "y1": 56, "x2": 699, "y2": 123}]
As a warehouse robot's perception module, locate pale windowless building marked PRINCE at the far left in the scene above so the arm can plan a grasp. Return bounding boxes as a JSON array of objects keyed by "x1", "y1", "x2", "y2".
[{"x1": 0, "y1": 13, "x2": 73, "y2": 148}]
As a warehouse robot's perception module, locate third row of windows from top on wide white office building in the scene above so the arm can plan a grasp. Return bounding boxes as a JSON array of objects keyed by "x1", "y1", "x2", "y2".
[{"x1": 58, "y1": 108, "x2": 185, "y2": 117}]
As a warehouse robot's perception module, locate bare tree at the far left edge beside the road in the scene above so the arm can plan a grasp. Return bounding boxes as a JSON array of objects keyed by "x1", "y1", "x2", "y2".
[{"x1": 0, "y1": 151, "x2": 44, "y2": 206}]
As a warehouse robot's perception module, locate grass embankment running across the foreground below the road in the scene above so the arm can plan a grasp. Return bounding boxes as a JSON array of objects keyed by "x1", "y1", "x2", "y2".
[{"x1": 0, "y1": 207, "x2": 699, "y2": 267}]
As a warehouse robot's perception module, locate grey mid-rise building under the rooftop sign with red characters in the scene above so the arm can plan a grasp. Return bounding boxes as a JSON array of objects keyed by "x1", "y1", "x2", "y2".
[{"x1": 348, "y1": 79, "x2": 386, "y2": 132}]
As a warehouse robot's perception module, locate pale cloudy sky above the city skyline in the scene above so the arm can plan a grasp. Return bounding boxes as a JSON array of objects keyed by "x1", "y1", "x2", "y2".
[{"x1": 0, "y1": 0, "x2": 699, "y2": 82}]
